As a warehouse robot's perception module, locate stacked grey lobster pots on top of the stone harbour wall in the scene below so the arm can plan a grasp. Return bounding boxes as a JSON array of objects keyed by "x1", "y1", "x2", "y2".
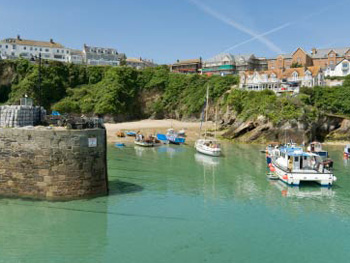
[{"x1": 0, "y1": 105, "x2": 46, "y2": 127}]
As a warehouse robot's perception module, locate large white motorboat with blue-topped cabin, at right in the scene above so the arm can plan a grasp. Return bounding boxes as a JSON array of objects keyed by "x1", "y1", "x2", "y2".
[{"x1": 270, "y1": 147, "x2": 337, "y2": 186}]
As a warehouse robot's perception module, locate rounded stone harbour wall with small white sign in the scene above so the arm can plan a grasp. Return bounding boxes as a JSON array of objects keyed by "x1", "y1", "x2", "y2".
[{"x1": 0, "y1": 127, "x2": 108, "y2": 200}]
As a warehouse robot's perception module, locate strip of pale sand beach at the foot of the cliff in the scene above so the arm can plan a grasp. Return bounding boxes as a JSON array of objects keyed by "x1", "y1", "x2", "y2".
[{"x1": 105, "y1": 119, "x2": 219, "y2": 143}]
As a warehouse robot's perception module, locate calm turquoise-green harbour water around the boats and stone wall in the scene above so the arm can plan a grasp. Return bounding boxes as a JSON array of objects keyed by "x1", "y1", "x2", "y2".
[{"x1": 0, "y1": 144, "x2": 350, "y2": 263}]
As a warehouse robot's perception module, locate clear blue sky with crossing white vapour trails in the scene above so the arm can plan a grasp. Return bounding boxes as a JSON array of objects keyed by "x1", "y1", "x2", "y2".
[{"x1": 0, "y1": 0, "x2": 350, "y2": 63}]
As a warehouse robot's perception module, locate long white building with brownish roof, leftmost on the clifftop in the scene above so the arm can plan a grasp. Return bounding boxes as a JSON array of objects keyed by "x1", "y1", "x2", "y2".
[{"x1": 0, "y1": 35, "x2": 70, "y2": 62}]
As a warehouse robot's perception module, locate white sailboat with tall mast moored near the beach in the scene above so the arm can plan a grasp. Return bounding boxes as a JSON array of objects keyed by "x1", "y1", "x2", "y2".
[{"x1": 194, "y1": 86, "x2": 221, "y2": 157}]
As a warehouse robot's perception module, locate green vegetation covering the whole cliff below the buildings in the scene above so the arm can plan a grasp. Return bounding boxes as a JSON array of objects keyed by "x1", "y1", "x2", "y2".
[{"x1": 0, "y1": 60, "x2": 350, "y2": 124}]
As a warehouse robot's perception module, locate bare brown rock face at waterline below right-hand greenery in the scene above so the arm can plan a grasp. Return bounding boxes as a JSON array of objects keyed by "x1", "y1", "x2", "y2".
[{"x1": 221, "y1": 111, "x2": 350, "y2": 143}]
